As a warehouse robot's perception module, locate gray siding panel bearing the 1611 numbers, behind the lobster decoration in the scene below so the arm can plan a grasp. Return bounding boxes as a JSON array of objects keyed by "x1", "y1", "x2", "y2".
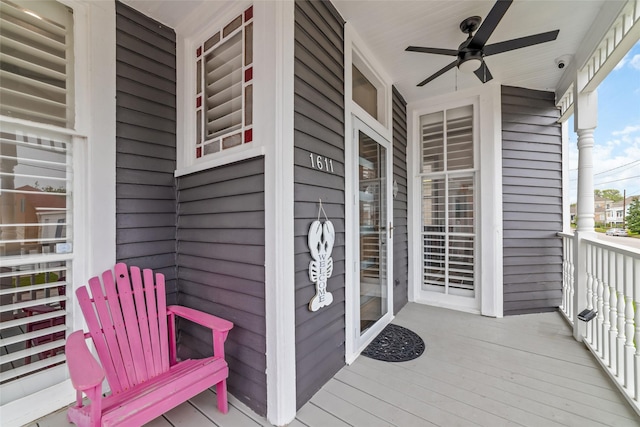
[{"x1": 294, "y1": 0, "x2": 345, "y2": 408}]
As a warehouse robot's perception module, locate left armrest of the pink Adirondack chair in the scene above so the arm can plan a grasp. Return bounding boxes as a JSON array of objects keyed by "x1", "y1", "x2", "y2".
[{"x1": 65, "y1": 331, "x2": 104, "y2": 391}]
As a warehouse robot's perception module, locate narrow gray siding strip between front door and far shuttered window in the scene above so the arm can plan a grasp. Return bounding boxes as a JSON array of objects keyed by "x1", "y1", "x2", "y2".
[{"x1": 393, "y1": 87, "x2": 409, "y2": 313}]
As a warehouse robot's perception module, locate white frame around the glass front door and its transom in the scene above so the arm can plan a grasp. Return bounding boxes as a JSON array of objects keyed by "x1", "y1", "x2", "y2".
[{"x1": 344, "y1": 22, "x2": 393, "y2": 365}]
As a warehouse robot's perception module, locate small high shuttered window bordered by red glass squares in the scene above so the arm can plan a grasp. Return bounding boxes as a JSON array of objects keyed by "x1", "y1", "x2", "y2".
[{"x1": 195, "y1": 7, "x2": 253, "y2": 159}]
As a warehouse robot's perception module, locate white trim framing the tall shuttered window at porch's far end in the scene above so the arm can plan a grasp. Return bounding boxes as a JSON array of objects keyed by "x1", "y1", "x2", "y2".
[{"x1": 407, "y1": 82, "x2": 503, "y2": 317}]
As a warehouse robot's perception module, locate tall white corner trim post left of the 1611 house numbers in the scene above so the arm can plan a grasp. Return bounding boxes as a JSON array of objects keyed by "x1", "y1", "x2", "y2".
[{"x1": 262, "y1": 1, "x2": 296, "y2": 425}]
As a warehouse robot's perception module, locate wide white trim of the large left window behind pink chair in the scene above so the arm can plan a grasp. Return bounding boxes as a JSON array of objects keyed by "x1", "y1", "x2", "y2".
[{"x1": 0, "y1": 0, "x2": 116, "y2": 426}]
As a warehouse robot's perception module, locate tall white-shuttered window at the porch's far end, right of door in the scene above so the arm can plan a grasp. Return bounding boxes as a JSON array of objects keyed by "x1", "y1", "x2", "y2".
[{"x1": 420, "y1": 106, "x2": 476, "y2": 297}]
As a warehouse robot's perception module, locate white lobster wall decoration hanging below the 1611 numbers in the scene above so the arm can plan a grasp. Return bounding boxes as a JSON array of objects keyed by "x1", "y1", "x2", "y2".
[{"x1": 307, "y1": 201, "x2": 336, "y2": 311}]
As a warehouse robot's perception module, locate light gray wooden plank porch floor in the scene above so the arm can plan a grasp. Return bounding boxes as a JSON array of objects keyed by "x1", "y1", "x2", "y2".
[{"x1": 32, "y1": 304, "x2": 640, "y2": 427}]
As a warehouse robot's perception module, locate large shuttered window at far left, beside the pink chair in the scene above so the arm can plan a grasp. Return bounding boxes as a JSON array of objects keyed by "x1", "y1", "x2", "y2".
[{"x1": 0, "y1": 0, "x2": 76, "y2": 404}]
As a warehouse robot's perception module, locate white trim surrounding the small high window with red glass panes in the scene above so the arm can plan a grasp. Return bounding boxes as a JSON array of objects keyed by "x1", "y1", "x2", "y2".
[{"x1": 175, "y1": 1, "x2": 264, "y2": 177}]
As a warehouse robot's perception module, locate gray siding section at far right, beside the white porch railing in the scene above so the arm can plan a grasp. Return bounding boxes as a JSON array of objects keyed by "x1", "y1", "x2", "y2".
[{"x1": 502, "y1": 86, "x2": 562, "y2": 315}]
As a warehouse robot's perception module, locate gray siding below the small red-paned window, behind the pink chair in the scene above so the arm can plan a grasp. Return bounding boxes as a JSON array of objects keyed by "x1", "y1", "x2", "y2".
[{"x1": 177, "y1": 157, "x2": 267, "y2": 415}]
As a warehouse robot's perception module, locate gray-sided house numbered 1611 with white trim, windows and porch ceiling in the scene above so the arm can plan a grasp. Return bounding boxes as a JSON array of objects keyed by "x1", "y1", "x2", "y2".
[{"x1": 0, "y1": 0, "x2": 638, "y2": 425}]
